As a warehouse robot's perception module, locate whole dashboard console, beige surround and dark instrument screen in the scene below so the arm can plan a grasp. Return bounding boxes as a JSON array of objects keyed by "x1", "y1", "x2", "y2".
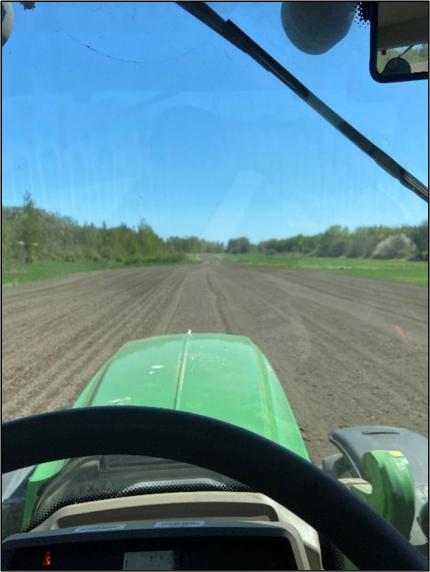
[{"x1": 2, "y1": 491, "x2": 322, "y2": 570}]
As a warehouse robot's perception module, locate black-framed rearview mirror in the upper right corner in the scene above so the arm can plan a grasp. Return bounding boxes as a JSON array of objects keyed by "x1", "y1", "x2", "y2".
[{"x1": 369, "y1": 1, "x2": 429, "y2": 83}]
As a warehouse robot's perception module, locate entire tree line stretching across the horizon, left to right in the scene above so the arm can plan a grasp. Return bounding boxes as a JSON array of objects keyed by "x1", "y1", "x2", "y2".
[{"x1": 2, "y1": 193, "x2": 428, "y2": 268}]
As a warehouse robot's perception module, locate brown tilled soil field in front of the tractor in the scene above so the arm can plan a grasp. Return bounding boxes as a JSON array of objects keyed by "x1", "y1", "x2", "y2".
[{"x1": 2, "y1": 257, "x2": 428, "y2": 461}]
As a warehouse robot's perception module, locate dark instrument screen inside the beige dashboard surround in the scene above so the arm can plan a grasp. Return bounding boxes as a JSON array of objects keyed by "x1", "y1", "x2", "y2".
[{"x1": 2, "y1": 521, "x2": 300, "y2": 570}]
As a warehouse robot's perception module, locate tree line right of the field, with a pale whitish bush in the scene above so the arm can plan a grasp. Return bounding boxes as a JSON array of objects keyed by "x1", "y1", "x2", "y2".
[{"x1": 226, "y1": 221, "x2": 428, "y2": 260}]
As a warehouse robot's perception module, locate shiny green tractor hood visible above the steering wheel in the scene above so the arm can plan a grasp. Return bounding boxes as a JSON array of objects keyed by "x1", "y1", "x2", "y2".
[{"x1": 79, "y1": 333, "x2": 308, "y2": 459}]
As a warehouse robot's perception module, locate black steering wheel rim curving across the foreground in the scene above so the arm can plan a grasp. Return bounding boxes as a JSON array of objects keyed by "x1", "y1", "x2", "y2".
[{"x1": 2, "y1": 406, "x2": 428, "y2": 570}]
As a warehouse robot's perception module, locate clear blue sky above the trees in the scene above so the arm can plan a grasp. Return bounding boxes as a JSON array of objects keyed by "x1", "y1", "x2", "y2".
[{"x1": 2, "y1": 2, "x2": 428, "y2": 240}]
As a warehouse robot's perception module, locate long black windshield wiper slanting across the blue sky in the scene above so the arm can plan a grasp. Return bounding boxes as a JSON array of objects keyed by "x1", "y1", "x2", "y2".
[{"x1": 177, "y1": 1, "x2": 429, "y2": 202}]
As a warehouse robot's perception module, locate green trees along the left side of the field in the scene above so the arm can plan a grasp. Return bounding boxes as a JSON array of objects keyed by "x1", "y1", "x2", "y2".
[{"x1": 2, "y1": 193, "x2": 224, "y2": 268}]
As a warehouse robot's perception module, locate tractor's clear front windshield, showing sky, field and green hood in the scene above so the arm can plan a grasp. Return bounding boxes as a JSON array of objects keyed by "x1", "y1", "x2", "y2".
[{"x1": 2, "y1": 2, "x2": 428, "y2": 529}]
